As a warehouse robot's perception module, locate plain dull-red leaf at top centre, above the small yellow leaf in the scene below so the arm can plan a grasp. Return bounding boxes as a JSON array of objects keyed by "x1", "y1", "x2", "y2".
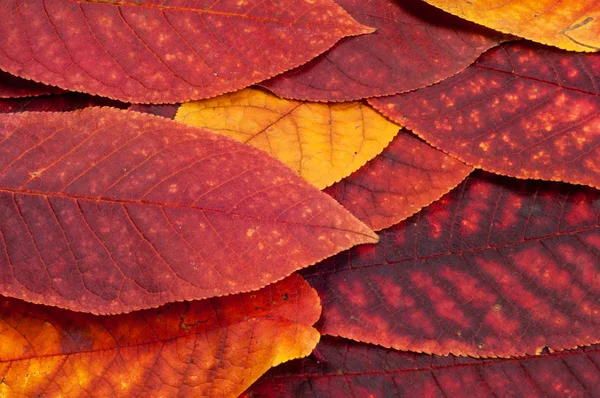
[{"x1": 261, "y1": 0, "x2": 502, "y2": 101}]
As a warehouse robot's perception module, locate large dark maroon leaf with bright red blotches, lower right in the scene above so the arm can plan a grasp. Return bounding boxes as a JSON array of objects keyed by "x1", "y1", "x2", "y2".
[{"x1": 306, "y1": 174, "x2": 600, "y2": 357}]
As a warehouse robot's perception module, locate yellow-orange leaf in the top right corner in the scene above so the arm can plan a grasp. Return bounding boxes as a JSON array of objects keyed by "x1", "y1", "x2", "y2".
[{"x1": 425, "y1": 0, "x2": 600, "y2": 51}]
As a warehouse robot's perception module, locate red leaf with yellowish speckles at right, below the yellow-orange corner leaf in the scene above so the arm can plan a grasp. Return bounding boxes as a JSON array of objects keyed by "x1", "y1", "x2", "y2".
[{"x1": 371, "y1": 42, "x2": 600, "y2": 187}]
